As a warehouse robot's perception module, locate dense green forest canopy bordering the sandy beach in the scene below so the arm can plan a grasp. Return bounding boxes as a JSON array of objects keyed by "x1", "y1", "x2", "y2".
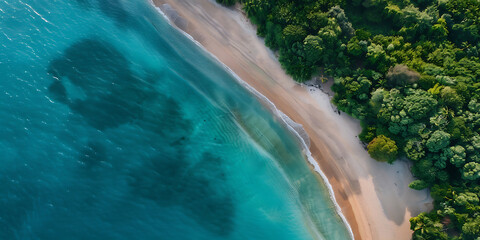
[{"x1": 217, "y1": 0, "x2": 480, "y2": 239}]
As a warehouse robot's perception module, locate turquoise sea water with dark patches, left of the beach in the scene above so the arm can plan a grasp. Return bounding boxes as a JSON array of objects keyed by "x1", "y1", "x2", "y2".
[{"x1": 0, "y1": 0, "x2": 349, "y2": 240}]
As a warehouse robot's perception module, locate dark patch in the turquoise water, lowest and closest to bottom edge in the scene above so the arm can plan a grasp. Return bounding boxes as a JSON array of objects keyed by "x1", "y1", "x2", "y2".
[{"x1": 131, "y1": 153, "x2": 235, "y2": 236}]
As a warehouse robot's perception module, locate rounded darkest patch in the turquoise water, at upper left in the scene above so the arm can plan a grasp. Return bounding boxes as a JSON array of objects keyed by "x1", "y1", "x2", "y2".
[{"x1": 49, "y1": 39, "x2": 156, "y2": 130}]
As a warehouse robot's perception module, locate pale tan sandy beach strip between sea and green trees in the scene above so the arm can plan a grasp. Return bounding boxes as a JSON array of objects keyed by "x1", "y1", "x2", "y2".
[{"x1": 153, "y1": 0, "x2": 431, "y2": 240}]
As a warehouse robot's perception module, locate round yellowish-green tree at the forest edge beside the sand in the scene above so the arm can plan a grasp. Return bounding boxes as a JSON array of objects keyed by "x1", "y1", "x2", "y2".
[{"x1": 367, "y1": 135, "x2": 398, "y2": 163}]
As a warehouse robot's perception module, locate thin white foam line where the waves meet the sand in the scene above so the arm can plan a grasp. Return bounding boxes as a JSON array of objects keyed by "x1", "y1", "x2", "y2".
[{"x1": 149, "y1": 3, "x2": 355, "y2": 239}]
